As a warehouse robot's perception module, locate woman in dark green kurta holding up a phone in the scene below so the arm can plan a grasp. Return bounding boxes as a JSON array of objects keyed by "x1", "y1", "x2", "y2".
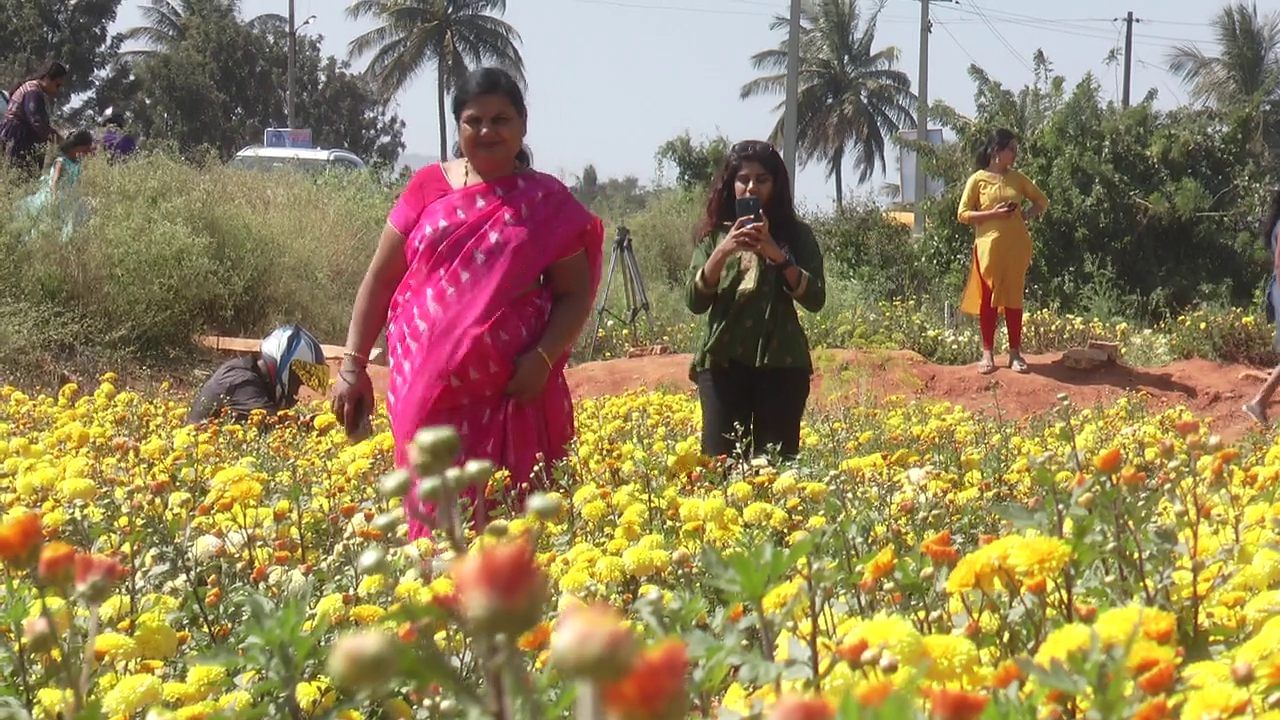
[{"x1": 686, "y1": 141, "x2": 827, "y2": 457}]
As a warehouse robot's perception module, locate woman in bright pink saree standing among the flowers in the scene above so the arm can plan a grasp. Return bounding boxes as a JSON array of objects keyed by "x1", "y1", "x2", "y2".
[{"x1": 334, "y1": 68, "x2": 604, "y2": 538}]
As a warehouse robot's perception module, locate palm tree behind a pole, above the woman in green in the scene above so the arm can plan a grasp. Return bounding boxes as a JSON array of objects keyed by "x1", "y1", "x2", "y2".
[{"x1": 741, "y1": 0, "x2": 915, "y2": 208}]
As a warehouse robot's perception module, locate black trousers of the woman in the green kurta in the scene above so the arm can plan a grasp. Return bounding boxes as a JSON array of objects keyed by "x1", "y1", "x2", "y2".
[{"x1": 698, "y1": 364, "x2": 810, "y2": 457}]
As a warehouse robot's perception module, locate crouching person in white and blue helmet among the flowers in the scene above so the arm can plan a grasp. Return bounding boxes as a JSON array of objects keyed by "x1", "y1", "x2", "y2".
[{"x1": 187, "y1": 324, "x2": 329, "y2": 424}]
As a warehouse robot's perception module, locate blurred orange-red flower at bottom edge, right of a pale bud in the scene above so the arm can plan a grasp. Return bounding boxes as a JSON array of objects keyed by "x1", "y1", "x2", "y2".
[{"x1": 604, "y1": 638, "x2": 689, "y2": 720}]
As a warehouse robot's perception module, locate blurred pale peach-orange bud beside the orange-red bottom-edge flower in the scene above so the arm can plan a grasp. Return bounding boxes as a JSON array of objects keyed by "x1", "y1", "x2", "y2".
[{"x1": 550, "y1": 603, "x2": 636, "y2": 680}]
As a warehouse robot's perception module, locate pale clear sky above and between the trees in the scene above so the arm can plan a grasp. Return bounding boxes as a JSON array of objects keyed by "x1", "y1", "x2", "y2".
[{"x1": 118, "y1": 0, "x2": 1228, "y2": 208}]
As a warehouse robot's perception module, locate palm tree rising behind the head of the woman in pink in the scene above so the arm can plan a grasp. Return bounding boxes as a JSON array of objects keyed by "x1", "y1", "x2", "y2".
[{"x1": 347, "y1": 0, "x2": 525, "y2": 159}]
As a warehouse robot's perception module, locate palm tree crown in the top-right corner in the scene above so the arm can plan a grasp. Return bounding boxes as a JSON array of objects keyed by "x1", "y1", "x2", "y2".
[{"x1": 1169, "y1": 3, "x2": 1280, "y2": 108}]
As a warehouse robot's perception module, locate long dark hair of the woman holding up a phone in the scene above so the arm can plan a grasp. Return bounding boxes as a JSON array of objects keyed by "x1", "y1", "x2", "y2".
[{"x1": 694, "y1": 140, "x2": 799, "y2": 242}]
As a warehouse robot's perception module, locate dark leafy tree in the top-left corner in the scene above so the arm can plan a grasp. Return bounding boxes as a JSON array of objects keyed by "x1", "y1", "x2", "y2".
[{"x1": 0, "y1": 0, "x2": 120, "y2": 96}]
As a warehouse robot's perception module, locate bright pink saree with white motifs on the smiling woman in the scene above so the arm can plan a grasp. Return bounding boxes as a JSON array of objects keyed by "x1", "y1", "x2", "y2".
[{"x1": 387, "y1": 165, "x2": 604, "y2": 538}]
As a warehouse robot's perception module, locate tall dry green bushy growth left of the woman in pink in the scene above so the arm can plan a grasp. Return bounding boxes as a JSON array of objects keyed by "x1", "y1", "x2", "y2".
[{"x1": 0, "y1": 155, "x2": 394, "y2": 376}]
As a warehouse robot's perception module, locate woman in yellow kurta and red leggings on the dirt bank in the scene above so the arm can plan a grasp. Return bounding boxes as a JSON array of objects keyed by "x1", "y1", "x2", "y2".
[{"x1": 956, "y1": 128, "x2": 1048, "y2": 375}]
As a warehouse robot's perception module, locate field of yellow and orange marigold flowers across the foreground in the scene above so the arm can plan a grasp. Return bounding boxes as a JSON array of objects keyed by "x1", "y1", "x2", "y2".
[{"x1": 0, "y1": 375, "x2": 1280, "y2": 720}]
